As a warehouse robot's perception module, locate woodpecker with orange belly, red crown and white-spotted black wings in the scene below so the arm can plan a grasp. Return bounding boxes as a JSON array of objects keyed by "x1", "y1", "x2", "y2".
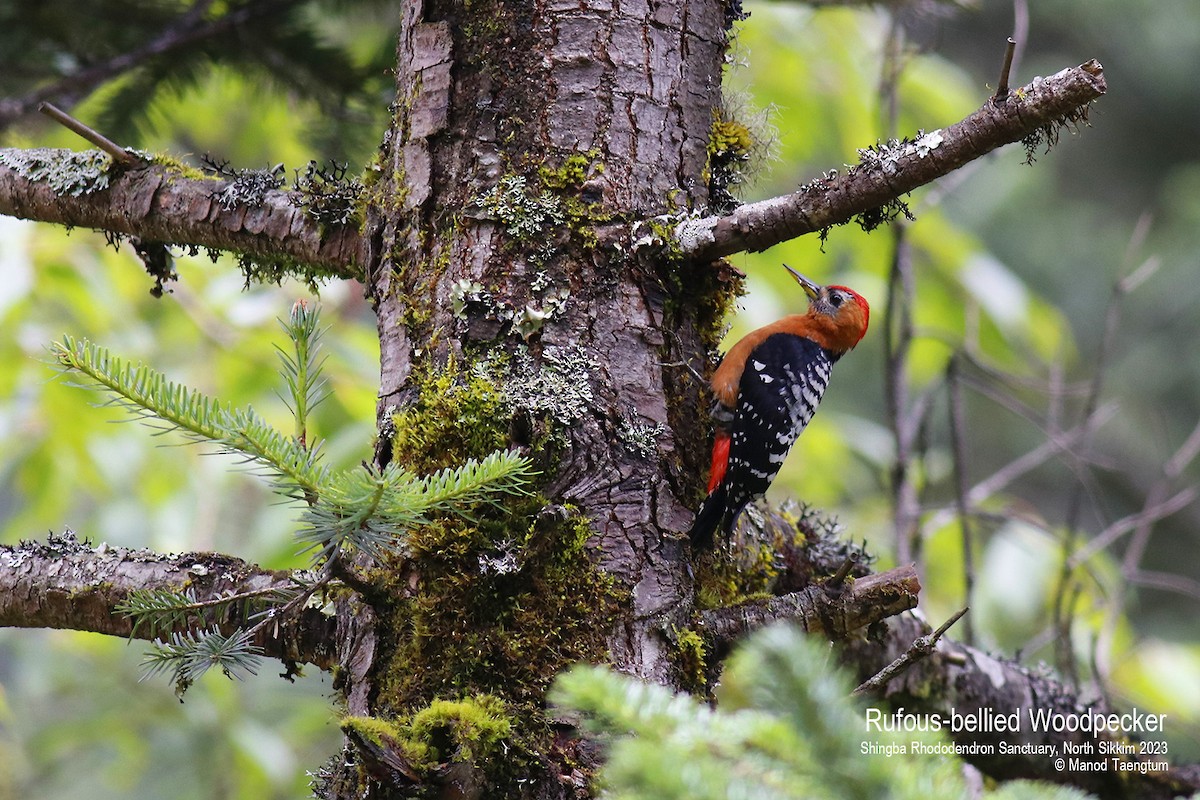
[{"x1": 691, "y1": 264, "x2": 871, "y2": 547}]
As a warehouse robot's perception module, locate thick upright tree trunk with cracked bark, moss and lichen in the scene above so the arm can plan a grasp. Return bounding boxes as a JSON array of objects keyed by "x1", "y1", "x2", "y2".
[{"x1": 336, "y1": 0, "x2": 726, "y2": 796}]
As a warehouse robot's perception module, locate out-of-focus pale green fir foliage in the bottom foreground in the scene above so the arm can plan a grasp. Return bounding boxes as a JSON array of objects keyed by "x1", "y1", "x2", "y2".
[{"x1": 551, "y1": 625, "x2": 1088, "y2": 800}]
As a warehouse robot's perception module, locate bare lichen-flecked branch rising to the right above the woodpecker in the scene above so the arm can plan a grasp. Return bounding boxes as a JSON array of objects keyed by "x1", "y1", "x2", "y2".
[{"x1": 674, "y1": 60, "x2": 1106, "y2": 261}]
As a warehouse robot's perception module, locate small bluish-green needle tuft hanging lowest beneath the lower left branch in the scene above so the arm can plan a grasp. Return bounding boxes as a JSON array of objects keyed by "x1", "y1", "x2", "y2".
[{"x1": 142, "y1": 626, "x2": 263, "y2": 697}]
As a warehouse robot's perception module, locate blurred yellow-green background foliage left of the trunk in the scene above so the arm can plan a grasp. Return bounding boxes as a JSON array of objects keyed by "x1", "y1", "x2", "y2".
[{"x1": 0, "y1": 4, "x2": 384, "y2": 800}]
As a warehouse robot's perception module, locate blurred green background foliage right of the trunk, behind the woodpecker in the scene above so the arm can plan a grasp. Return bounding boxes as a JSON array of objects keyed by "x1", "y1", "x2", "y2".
[{"x1": 727, "y1": 0, "x2": 1200, "y2": 760}]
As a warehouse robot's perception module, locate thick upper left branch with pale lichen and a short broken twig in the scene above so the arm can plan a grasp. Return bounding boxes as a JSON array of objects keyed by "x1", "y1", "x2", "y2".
[{"x1": 0, "y1": 149, "x2": 362, "y2": 278}]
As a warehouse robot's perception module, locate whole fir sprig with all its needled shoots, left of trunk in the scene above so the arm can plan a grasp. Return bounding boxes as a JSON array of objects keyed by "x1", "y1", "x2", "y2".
[{"x1": 53, "y1": 302, "x2": 533, "y2": 696}]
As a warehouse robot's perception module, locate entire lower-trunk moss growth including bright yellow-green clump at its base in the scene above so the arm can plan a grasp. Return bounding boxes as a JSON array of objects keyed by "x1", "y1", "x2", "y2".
[{"x1": 364, "y1": 497, "x2": 626, "y2": 796}]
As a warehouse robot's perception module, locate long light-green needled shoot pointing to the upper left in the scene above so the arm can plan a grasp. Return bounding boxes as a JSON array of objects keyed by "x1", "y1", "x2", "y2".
[{"x1": 53, "y1": 336, "x2": 328, "y2": 497}]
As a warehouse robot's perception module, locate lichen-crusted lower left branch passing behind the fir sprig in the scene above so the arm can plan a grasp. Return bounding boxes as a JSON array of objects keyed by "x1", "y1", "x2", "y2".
[{"x1": 0, "y1": 533, "x2": 337, "y2": 669}]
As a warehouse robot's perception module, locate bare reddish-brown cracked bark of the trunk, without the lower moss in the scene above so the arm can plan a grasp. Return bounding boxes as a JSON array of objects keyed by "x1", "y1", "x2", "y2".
[{"x1": 367, "y1": 0, "x2": 725, "y2": 714}]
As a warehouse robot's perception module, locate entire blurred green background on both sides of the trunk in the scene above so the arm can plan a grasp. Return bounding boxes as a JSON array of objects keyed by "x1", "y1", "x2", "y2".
[{"x1": 0, "y1": 0, "x2": 1200, "y2": 799}]
